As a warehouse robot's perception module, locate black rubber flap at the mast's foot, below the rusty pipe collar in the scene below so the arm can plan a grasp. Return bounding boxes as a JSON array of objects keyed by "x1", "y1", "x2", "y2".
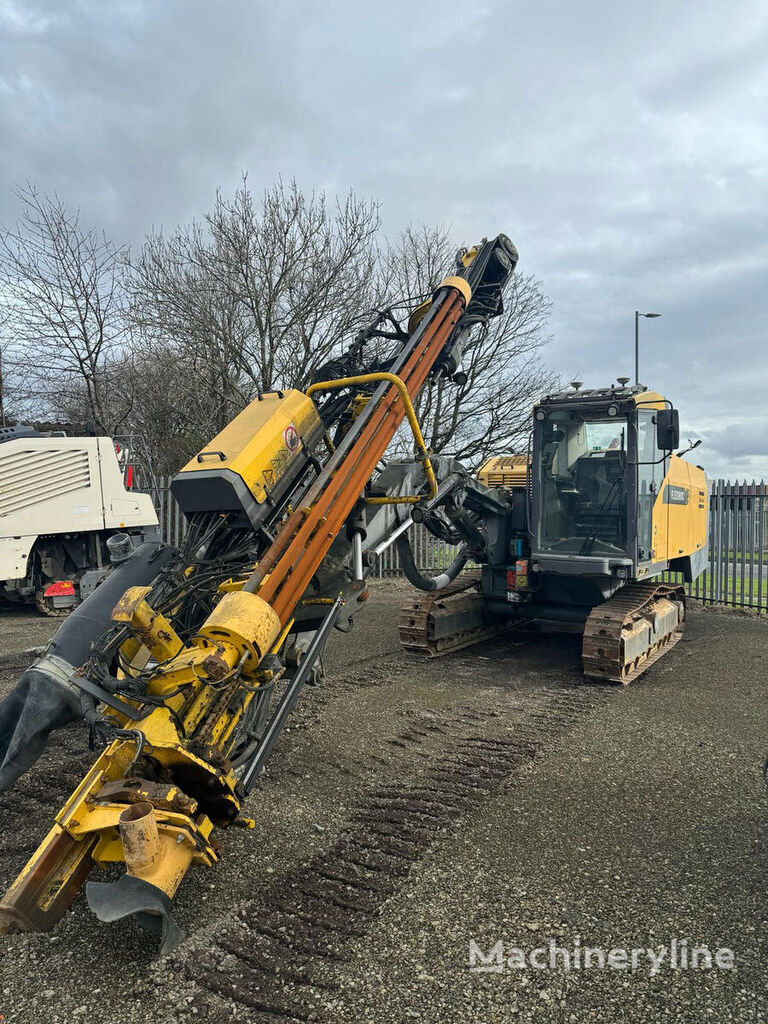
[{"x1": 85, "y1": 874, "x2": 184, "y2": 955}]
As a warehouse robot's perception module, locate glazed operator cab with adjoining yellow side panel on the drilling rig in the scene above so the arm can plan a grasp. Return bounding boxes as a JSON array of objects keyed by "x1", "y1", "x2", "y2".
[{"x1": 529, "y1": 383, "x2": 707, "y2": 599}]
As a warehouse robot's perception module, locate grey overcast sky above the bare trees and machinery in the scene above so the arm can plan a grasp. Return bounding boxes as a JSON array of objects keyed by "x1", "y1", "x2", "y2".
[{"x1": 0, "y1": 0, "x2": 768, "y2": 478}]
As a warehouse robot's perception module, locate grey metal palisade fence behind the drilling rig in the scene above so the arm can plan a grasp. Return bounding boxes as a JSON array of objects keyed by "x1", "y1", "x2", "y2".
[{"x1": 147, "y1": 478, "x2": 768, "y2": 611}]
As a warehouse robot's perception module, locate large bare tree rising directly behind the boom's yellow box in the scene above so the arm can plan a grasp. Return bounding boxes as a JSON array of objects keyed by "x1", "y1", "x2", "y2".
[{"x1": 133, "y1": 178, "x2": 379, "y2": 434}]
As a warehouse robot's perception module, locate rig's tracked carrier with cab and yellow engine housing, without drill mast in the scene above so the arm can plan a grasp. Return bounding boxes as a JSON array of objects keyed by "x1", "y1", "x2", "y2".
[{"x1": 396, "y1": 378, "x2": 709, "y2": 684}]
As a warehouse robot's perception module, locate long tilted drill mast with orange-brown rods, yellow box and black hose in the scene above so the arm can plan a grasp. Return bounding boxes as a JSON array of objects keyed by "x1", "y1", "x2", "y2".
[{"x1": 0, "y1": 234, "x2": 517, "y2": 952}]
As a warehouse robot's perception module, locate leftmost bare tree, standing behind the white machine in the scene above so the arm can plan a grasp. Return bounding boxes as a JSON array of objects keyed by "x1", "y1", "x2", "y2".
[{"x1": 0, "y1": 185, "x2": 130, "y2": 433}]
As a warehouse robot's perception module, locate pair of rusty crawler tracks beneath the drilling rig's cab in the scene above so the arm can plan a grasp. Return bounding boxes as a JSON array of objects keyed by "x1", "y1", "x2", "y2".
[{"x1": 399, "y1": 570, "x2": 685, "y2": 684}]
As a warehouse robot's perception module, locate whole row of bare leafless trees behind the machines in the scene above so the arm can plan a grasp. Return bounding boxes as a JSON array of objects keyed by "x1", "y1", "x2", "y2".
[{"x1": 0, "y1": 178, "x2": 553, "y2": 473}]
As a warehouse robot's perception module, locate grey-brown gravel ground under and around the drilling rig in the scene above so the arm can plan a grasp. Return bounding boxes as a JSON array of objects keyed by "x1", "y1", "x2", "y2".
[{"x1": 0, "y1": 584, "x2": 768, "y2": 1024}]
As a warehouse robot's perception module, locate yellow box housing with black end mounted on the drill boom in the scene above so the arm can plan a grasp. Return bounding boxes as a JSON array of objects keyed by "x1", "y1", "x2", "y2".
[{"x1": 171, "y1": 390, "x2": 323, "y2": 525}]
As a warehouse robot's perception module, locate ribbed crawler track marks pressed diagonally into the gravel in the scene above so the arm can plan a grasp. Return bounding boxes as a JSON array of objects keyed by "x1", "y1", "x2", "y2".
[{"x1": 156, "y1": 685, "x2": 613, "y2": 1024}]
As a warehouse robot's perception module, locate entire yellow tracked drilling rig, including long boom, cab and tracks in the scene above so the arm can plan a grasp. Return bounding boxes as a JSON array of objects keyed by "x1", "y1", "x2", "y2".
[{"x1": 0, "y1": 228, "x2": 708, "y2": 952}]
